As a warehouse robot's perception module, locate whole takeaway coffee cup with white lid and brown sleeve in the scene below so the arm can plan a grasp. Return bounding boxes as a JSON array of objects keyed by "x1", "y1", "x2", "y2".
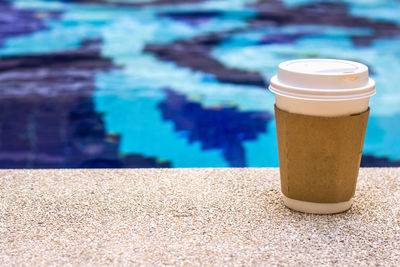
[{"x1": 269, "y1": 59, "x2": 375, "y2": 214}]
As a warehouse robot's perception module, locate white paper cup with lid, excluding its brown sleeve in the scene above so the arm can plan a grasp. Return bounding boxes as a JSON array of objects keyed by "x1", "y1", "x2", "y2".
[{"x1": 269, "y1": 59, "x2": 375, "y2": 214}]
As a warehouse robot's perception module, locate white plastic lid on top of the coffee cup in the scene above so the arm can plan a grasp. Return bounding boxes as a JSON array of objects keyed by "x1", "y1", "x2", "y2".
[{"x1": 269, "y1": 59, "x2": 376, "y2": 101}]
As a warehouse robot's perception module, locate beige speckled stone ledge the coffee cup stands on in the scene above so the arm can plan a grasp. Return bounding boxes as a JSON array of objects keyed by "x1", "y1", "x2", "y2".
[{"x1": 0, "y1": 168, "x2": 400, "y2": 266}]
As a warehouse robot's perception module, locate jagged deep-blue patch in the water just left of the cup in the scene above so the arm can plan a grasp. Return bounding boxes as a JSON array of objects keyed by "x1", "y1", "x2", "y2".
[{"x1": 159, "y1": 89, "x2": 273, "y2": 167}]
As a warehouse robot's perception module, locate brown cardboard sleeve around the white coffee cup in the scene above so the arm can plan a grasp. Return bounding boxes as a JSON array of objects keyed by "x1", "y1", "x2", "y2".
[{"x1": 275, "y1": 106, "x2": 369, "y2": 203}]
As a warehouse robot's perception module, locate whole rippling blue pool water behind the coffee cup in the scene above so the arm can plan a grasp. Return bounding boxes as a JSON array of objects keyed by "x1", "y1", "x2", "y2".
[{"x1": 0, "y1": 0, "x2": 400, "y2": 168}]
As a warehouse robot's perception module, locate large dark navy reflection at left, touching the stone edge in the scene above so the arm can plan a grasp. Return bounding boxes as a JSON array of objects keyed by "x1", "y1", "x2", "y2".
[{"x1": 0, "y1": 40, "x2": 170, "y2": 168}]
